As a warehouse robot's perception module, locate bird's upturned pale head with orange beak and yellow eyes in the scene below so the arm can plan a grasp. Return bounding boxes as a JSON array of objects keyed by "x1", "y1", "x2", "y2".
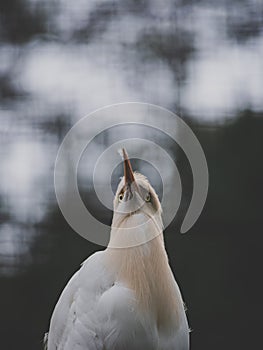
[{"x1": 112, "y1": 149, "x2": 163, "y2": 245}]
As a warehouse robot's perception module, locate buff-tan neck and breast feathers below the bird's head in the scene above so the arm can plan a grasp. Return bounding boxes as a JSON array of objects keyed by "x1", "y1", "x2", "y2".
[{"x1": 106, "y1": 233, "x2": 182, "y2": 328}]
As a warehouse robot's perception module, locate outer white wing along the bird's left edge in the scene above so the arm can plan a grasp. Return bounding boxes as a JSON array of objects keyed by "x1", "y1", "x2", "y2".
[{"x1": 47, "y1": 252, "x2": 111, "y2": 350}]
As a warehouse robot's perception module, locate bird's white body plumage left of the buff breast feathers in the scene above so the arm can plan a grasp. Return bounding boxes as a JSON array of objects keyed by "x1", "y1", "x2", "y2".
[{"x1": 47, "y1": 252, "x2": 158, "y2": 350}]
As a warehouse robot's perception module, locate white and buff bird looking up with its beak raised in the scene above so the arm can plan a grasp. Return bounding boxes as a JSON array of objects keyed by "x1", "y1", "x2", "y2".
[{"x1": 44, "y1": 148, "x2": 189, "y2": 350}]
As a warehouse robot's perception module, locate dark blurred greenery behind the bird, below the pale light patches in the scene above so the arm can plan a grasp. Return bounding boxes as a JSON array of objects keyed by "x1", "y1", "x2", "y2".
[{"x1": 0, "y1": 111, "x2": 263, "y2": 350}]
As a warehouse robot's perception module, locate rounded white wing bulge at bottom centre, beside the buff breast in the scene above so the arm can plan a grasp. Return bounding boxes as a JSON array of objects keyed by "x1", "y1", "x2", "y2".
[{"x1": 96, "y1": 282, "x2": 161, "y2": 350}]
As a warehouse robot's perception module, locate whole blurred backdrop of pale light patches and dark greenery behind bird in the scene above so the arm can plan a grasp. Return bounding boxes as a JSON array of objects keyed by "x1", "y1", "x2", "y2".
[{"x1": 0, "y1": 0, "x2": 263, "y2": 350}]
